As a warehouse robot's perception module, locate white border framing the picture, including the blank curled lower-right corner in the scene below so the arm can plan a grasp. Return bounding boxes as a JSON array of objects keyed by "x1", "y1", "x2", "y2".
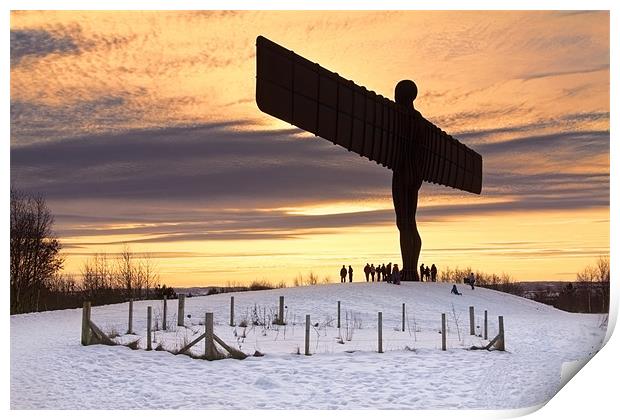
[{"x1": 0, "y1": 0, "x2": 620, "y2": 420}]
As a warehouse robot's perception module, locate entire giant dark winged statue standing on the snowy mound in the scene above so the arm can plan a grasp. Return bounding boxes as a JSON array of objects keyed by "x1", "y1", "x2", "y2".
[{"x1": 256, "y1": 36, "x2": 482, "y2": 281}]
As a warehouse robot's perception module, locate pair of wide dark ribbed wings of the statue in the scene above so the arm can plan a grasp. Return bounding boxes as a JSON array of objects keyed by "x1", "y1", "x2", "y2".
[{"x1": 256, "y1": 36, "x2": 482, "y2": 194}]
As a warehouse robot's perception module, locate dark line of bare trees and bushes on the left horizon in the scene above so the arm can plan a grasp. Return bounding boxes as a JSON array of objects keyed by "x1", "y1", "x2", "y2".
[{"x1": 10, "y1": 188, "x2": 176, "y2": 314}]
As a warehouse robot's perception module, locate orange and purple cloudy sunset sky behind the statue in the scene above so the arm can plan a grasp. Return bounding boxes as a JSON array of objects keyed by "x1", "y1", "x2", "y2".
[{"x1": 10, "y1": 11, "x2": 610, "y2": 286}]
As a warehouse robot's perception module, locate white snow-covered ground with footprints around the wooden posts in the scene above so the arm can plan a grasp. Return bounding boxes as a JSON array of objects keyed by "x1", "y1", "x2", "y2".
[{"x1": 11, "y1": 283, "x2": 605, "y2": 409}]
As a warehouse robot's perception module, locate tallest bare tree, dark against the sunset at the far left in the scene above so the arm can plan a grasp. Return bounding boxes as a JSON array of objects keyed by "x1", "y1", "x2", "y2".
[{"x1": 10, "y1": 188, "x2": 64, "y2": 313}]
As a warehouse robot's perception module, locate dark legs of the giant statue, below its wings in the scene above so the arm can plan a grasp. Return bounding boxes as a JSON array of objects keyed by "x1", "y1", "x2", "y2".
[{"x1": 392, "y1": 171, "x2": 422, "y2": 281}]
